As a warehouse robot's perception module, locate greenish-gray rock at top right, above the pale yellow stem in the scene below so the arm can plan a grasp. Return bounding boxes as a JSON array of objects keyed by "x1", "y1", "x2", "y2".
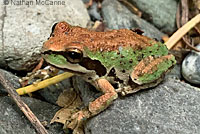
[{"x1": 129, "y1": 0, "x2": 177, "y2": 33}]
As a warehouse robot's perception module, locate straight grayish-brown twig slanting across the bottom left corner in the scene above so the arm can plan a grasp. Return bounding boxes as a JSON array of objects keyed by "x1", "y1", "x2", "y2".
[{"x1": 0, "y1": 71, "x2": 48, "y2": 134}]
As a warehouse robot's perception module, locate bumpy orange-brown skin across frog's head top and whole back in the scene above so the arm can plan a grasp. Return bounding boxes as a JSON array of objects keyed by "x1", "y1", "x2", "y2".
[{"x1": 43, "y1": 22, "x2": 156, "y2": 52}]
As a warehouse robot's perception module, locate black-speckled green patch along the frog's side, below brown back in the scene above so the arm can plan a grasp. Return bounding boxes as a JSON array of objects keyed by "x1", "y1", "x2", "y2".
[{"x1": 85, "y1": 43, "x2": 168, "y2": 70}]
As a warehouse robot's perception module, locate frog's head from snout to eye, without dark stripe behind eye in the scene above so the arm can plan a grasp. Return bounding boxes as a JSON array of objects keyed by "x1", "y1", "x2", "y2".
[{"x1": 42, "y1": 22, "x2": 87, "y2": 73}]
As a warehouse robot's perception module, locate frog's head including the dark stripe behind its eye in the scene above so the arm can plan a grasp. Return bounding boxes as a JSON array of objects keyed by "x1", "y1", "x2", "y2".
[{"x1": 42, "y1": 22, "x2": 105, "y2": 74}]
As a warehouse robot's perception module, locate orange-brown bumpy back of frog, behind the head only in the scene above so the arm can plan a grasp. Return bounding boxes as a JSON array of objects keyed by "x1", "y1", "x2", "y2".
[{"x1": 72, "y1": 28, "x2": 156, "y2": 51}]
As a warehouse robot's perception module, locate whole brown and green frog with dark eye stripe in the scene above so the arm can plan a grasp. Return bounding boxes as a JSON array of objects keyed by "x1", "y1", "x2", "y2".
[{"x1": 42, "y1": 21, "x2": 176, "y2": 132}]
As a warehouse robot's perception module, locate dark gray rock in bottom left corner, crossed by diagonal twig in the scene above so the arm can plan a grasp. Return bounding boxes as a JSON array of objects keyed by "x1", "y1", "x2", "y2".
[{"x1": 0, "y1": 96, "x2": 64, "y2": 134}]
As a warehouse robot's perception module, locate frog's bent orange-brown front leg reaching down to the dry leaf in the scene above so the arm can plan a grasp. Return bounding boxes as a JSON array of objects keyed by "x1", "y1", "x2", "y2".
[{"x1": 66, "y1": 79, "x2": 118, "y2": 134}]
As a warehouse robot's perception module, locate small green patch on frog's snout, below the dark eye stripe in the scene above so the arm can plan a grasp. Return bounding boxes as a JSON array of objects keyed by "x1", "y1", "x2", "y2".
[{"x1": 45, "y1": 54, "x2": 67, "y2": 65}]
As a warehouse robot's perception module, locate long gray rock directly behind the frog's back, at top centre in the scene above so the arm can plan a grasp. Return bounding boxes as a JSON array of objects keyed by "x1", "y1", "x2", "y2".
[{"x1": 102, "y1": 0, "x2": 164, "y2": 40}]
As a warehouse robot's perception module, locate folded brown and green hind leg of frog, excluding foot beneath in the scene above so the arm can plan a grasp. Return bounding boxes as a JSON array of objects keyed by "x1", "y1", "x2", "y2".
[{"x1": 130, "y1": 55, "x2": 176, "y2": 85}]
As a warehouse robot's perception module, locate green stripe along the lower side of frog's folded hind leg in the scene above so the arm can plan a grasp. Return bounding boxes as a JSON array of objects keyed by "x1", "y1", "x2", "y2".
[{"x1": 139, "y1": 56, "x2": 176, "y2": 83}]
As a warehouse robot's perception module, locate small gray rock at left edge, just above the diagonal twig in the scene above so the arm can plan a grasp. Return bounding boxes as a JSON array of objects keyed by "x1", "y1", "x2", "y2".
[{"x1": 0, "y1": 69, "x2": 21, "y2": 94}]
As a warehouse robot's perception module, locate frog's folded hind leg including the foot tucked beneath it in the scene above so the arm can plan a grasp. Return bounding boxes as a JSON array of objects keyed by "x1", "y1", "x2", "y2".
[{"x1": 121, "y1": 55, "x2": 176, "y2": 95}]
